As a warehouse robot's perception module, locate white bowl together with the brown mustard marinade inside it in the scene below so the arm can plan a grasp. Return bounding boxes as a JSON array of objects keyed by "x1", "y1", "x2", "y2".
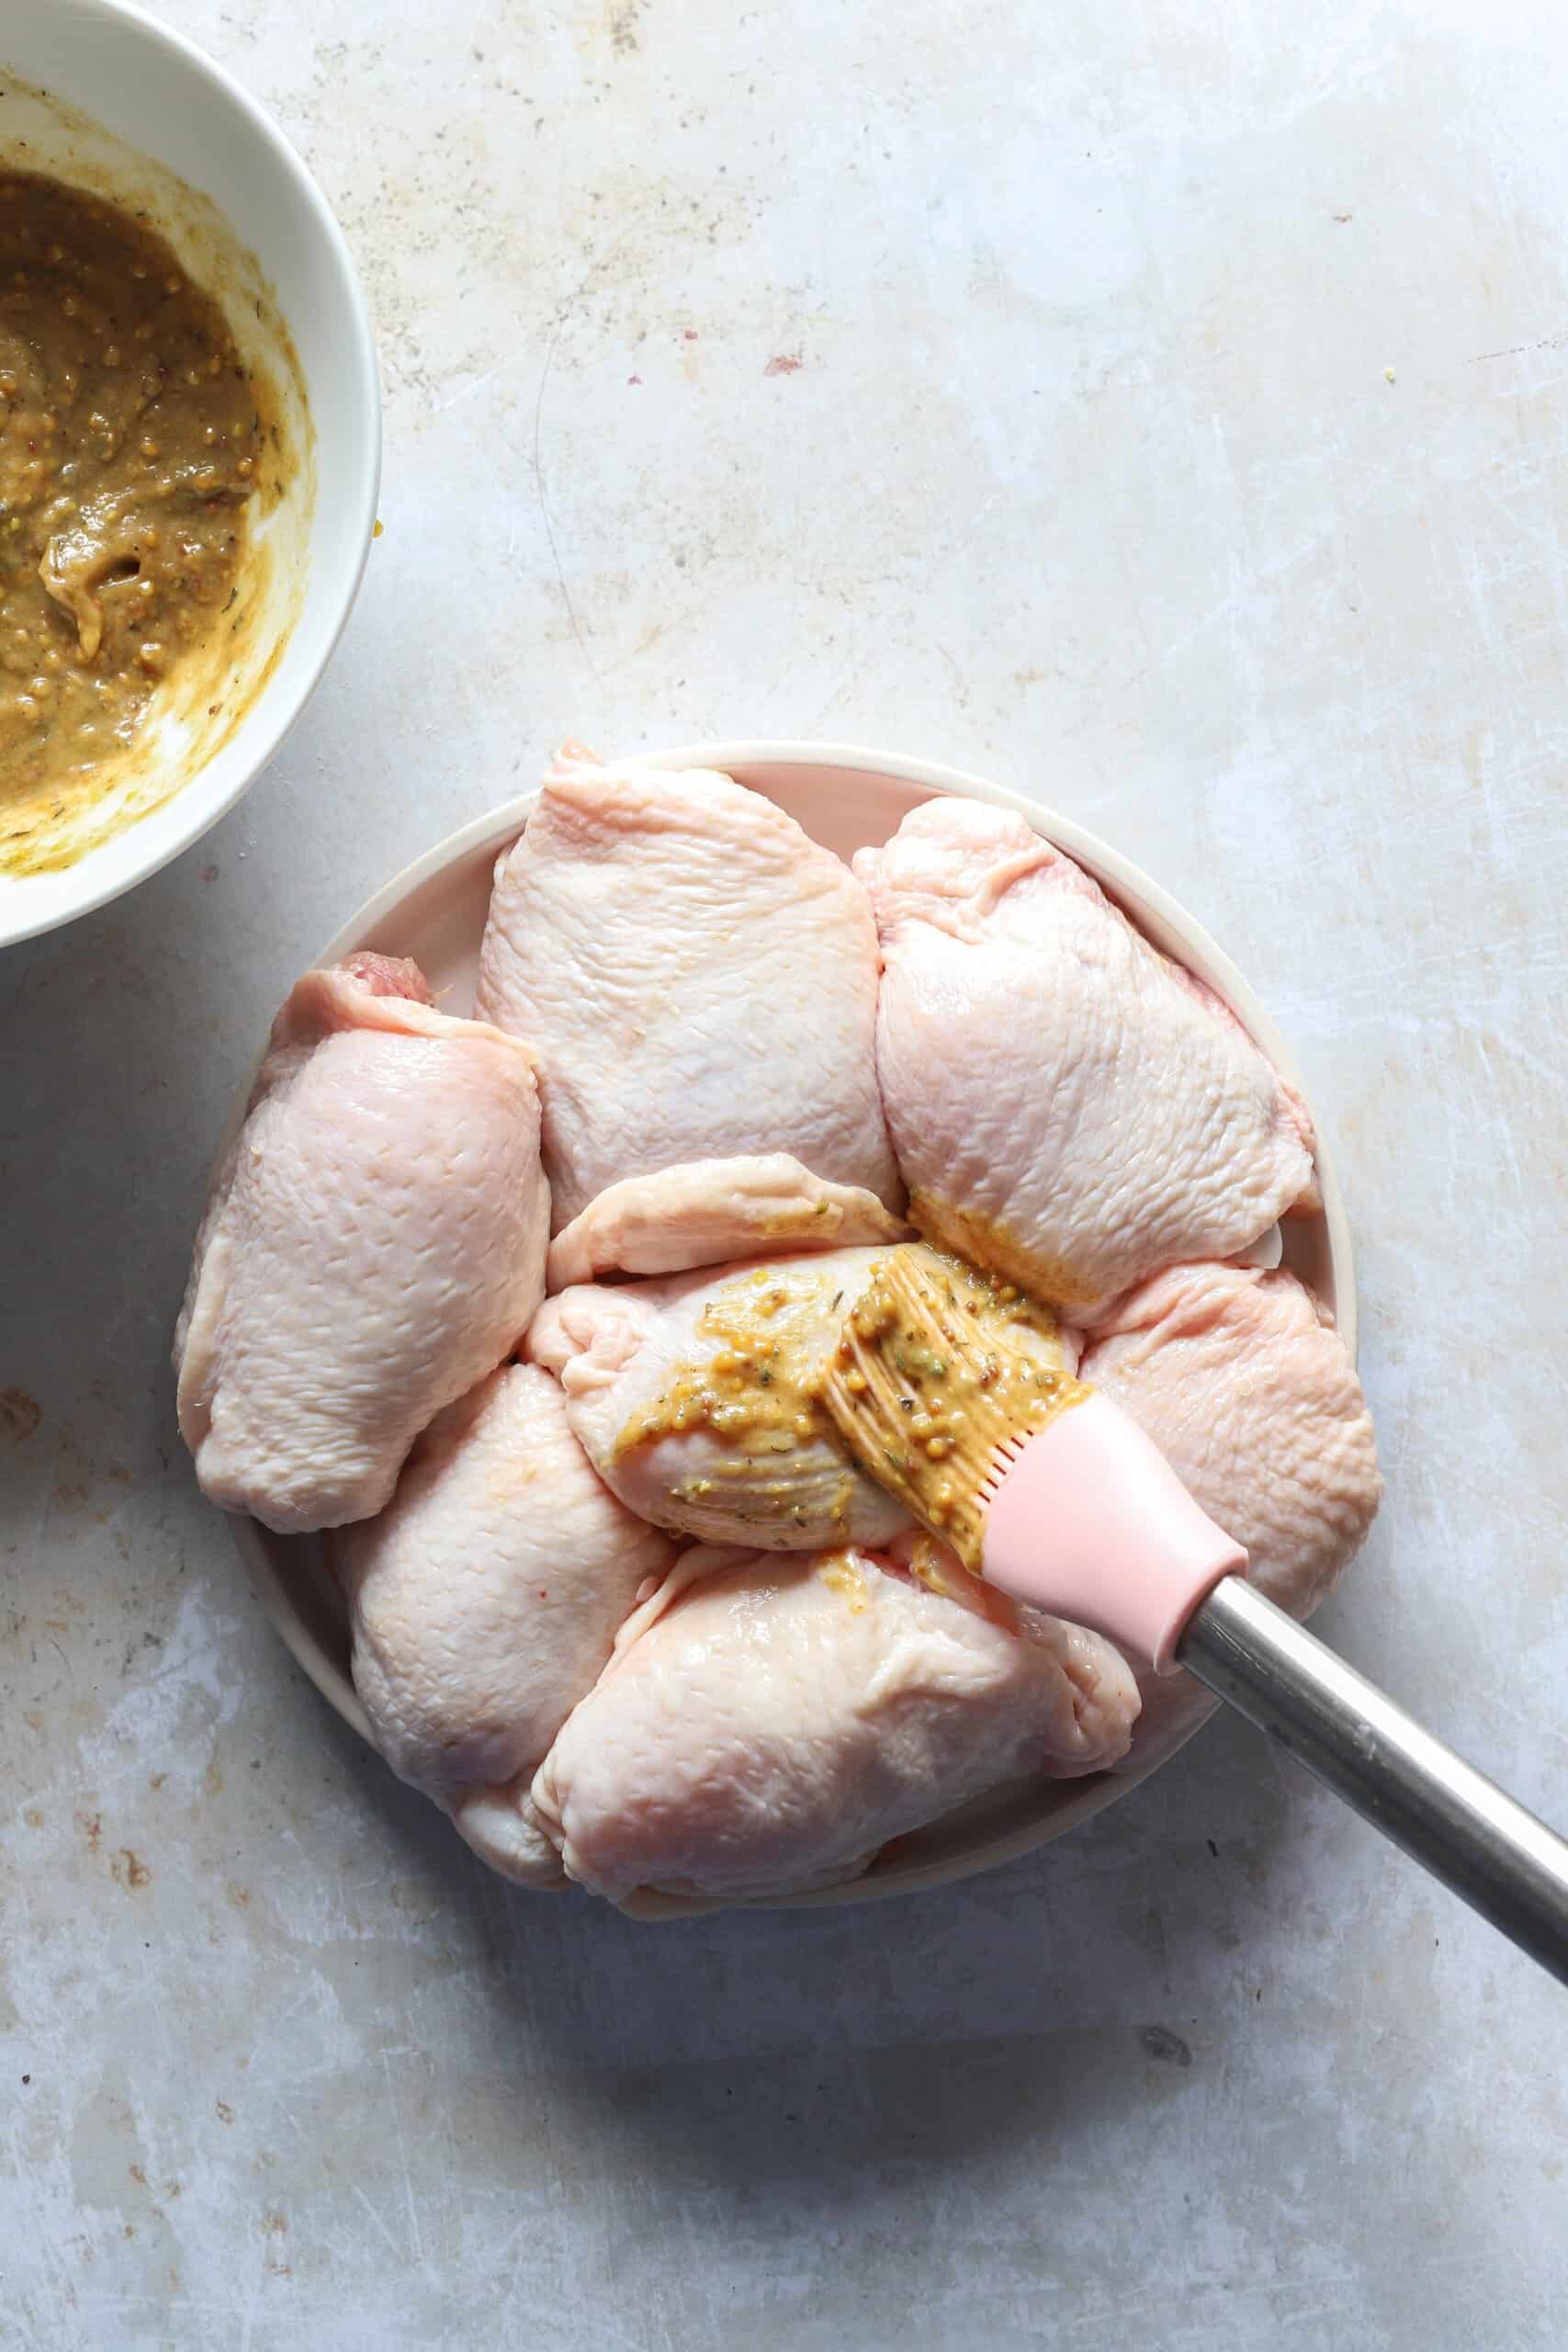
[{"x1": 0, "y1": 0, "x2": 381, "y2": 945}]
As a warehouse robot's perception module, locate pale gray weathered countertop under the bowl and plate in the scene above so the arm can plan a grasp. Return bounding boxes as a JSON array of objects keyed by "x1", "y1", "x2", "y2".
[{"x1": 0, "y1": 0, "x2": 1568, "y2": 2352}]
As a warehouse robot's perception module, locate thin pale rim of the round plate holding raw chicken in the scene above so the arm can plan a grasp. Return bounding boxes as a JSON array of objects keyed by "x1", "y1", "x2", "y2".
[{"x1": 219, "y1": 739, "x2": 1357, "y2": 1922}]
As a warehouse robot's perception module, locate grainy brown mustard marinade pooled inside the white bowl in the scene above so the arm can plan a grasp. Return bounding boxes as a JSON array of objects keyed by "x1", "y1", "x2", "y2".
[{"x1": 0, "y1": 172, "x2": 275, "y2": 868}]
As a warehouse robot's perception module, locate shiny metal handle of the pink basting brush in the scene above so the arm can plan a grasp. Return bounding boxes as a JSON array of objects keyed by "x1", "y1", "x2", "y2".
[{"x1": 1176, "y1": 1576, "x2": 1568, "y2": 1985}]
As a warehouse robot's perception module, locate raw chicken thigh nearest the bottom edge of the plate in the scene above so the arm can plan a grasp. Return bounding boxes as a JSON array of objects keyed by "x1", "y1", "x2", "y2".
[{"x1": 534, "y1": 1550, "x2": 1138, "y2": 1900}]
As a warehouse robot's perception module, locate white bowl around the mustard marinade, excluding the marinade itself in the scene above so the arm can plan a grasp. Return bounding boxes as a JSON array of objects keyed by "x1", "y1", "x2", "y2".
[{"x1": 0, "y1": 0, "x2": 381, "y2": 945}]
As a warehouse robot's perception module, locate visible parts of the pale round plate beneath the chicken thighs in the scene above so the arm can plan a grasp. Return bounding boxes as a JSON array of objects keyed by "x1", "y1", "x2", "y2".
[{"x1": 223, "y1": 743, "x2": 1357, "y2": 1917}]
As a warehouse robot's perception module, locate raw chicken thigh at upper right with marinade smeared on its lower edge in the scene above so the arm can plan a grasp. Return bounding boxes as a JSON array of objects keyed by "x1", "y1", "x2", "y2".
[{"x1": 856, "y1": 799, "x2": 1312, "y2": 1319}]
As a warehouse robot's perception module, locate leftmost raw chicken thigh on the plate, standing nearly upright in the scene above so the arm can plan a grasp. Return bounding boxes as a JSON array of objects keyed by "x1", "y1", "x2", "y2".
[{"x1": 174, "y1": 955, "x2": 550, "y2": 1532}]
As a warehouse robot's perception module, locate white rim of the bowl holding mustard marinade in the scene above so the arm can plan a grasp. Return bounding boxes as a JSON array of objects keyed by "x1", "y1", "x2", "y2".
[{"x1": 0, "y1": 0, "x2": 381, "y2": 948}]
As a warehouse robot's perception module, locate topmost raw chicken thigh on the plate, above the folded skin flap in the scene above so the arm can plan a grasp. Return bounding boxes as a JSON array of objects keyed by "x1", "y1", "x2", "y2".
[{"x1": 478, "y1": 746, "x2": 903, "y2": 1263}]
